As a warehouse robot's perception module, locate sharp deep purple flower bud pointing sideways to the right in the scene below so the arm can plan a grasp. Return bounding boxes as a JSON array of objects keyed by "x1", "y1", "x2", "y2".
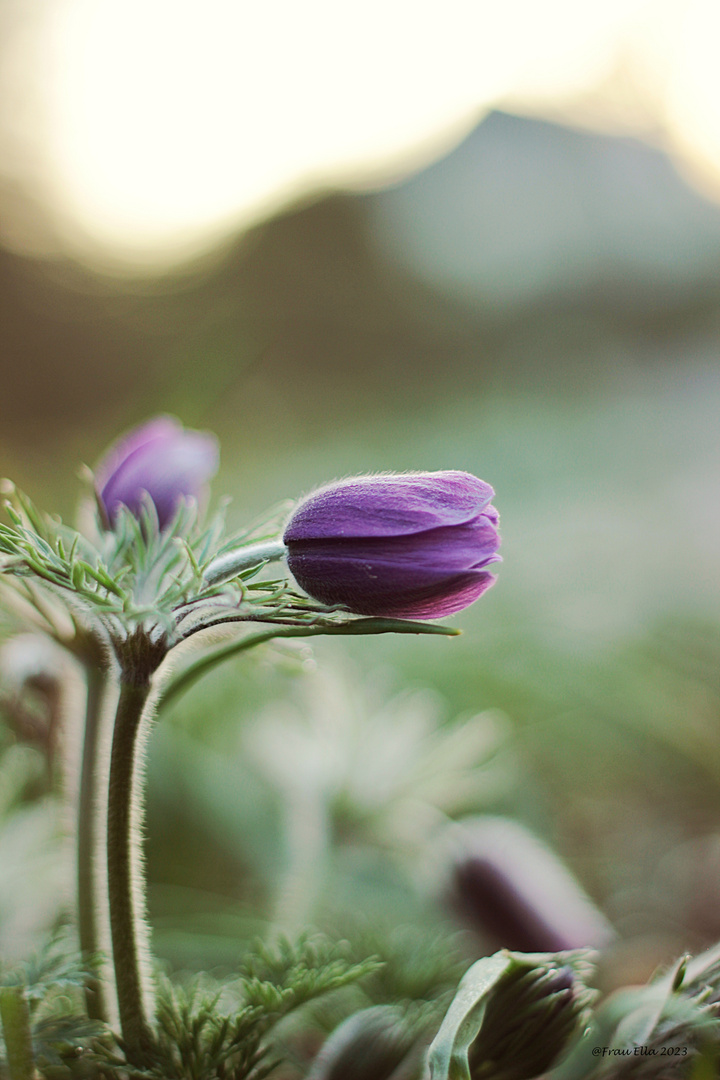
[{"x1": 284, "y1": 472, "x2": 500, "y2": 619}]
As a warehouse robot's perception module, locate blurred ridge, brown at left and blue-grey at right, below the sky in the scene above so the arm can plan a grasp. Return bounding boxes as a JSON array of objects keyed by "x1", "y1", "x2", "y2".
[{"x1": 0, "y1": 113, "x2": 720, "y2": 464}]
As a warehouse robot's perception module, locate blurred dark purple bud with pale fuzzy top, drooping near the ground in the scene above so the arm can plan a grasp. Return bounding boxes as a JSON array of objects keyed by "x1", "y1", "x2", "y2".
[{"x1": 449, "y1": 818, "x2": 614, "y2": 953}]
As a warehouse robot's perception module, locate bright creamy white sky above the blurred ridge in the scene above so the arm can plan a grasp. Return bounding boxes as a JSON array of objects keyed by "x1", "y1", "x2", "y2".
[{"x1": 5, "y1": 0, "x2": 720, "y2": 269}]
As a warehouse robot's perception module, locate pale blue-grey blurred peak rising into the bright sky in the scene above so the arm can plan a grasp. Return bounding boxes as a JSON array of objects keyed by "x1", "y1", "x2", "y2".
[{"x1": 371, "y1": 112, "x2": 720, "y2": 319}]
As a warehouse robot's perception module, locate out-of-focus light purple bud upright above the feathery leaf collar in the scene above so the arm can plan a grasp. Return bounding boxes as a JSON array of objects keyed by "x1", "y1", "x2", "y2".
[{"x1": 95, "y1": 416, "x2": 218, "y2": 528}]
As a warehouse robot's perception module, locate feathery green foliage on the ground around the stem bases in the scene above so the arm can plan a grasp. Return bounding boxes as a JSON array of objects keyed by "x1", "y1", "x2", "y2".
[{"x1": 0, "y1": 937, "x2": 380, "y2": 1080}]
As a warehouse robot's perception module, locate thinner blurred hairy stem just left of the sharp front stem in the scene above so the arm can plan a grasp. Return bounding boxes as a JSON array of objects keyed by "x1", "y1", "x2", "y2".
[{"x1": 78, "y1": 663, "x2": 110, "y2": 1021}]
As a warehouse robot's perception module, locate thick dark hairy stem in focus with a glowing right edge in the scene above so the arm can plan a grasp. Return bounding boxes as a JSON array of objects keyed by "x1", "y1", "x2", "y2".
[{"x1": 108, "y1": 671, "x2": 153, "y2": 1065}]
